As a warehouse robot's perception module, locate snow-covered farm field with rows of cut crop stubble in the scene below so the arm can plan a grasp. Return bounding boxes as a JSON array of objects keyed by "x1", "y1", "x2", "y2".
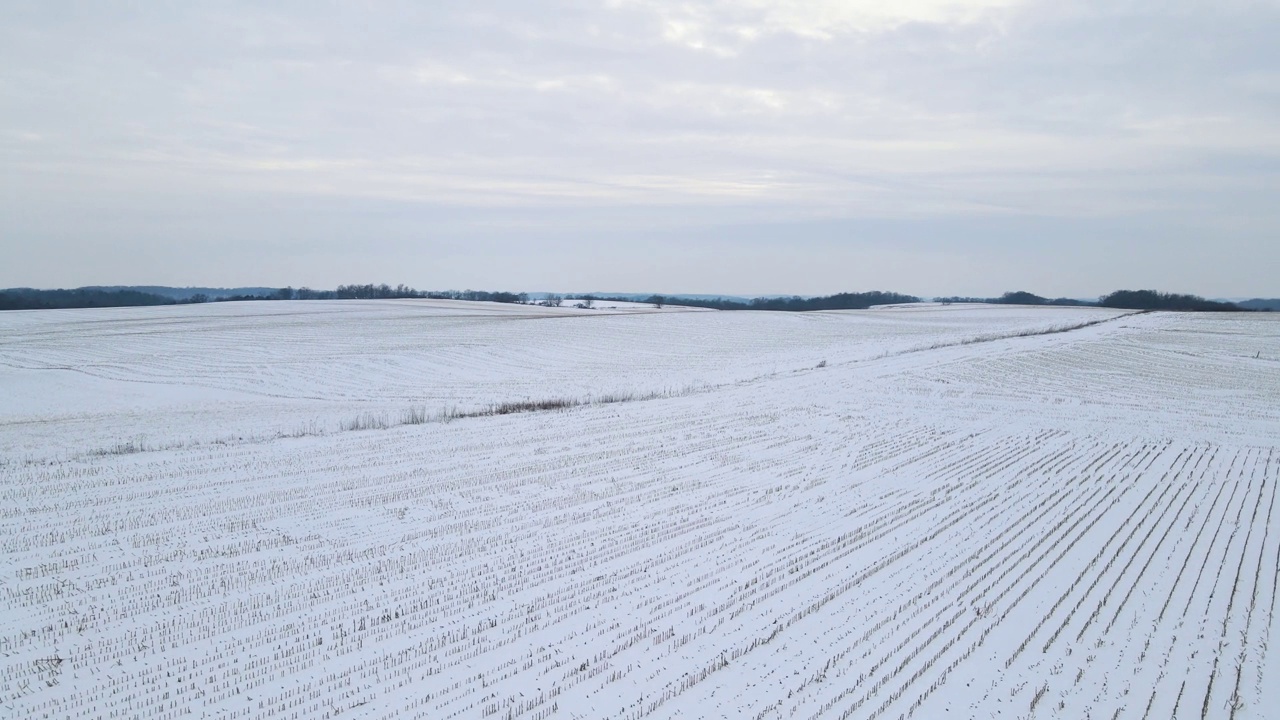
[{"x1": 0, "y1": 301, "x2": 1280, "y2": 720}]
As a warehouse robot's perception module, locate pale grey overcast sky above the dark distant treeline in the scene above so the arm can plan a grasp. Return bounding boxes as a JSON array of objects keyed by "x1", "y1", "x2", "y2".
[{"x1": 0, "y1": 0, "x2": 1280, "y2": 297}]
